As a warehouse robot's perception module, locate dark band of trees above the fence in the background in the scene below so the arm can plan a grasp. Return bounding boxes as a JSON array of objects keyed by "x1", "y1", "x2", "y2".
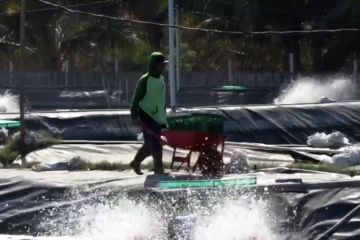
[{"x1": 0, "y1": 0, "x2": 360, "y2": 72}]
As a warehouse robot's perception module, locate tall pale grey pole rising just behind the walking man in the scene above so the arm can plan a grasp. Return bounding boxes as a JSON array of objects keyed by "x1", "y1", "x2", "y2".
[{"x1": 168, "y1": 0, "x2": 176, "y2": 111}]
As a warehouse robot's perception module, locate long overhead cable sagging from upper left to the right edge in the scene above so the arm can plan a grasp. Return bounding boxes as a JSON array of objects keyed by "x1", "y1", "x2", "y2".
[{"x1": 38, "y1": 0, "x2": 359, "y2": 35}]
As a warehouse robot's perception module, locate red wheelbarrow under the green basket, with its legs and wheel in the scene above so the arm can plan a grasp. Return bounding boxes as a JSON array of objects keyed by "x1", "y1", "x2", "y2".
[{"x1": 162, "y1": 130, "x2": 225, "y2": 175}]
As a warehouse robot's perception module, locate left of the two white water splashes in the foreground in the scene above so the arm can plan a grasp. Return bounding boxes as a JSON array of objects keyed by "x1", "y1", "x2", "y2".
[{"x1": 41, "y1": 199, "x2": 165, "y2": 240}]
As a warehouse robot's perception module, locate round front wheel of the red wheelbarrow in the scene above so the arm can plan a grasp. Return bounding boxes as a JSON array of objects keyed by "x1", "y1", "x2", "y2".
[{"x1": 197, "y1": 149, "x2": 222, "y2": 176}]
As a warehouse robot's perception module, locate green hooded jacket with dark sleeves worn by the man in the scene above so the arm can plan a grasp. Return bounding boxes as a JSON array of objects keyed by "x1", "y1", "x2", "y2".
[{"x1": 130, "y1": 52, "x2": 166, "y2": 125}]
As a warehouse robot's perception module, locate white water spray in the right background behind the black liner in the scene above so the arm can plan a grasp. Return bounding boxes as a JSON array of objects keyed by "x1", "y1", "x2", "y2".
[{"x1": 274, "y1": 77, "x2": 356, "y2": 104}]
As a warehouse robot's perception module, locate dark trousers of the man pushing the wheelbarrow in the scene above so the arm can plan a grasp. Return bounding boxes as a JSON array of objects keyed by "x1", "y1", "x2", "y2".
[{"x1": 134, "y1": 109, "x2": 164, "y2": 173}]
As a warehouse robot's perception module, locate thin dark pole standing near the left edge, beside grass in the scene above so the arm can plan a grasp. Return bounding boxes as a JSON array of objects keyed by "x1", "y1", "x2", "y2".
[{"x1": 19, "y1": 0, "x2": 26, "y2": 161}]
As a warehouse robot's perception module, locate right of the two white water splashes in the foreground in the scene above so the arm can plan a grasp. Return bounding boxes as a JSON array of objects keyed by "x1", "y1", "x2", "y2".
[{"x1": 194, "y1": 200, "x2": 282, "y2": 240}]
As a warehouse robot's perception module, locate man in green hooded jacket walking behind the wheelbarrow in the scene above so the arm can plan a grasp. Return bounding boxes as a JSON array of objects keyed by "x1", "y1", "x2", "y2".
[{"x1": 130, "y1": 52, "x2": 167, "y2": 175}]
